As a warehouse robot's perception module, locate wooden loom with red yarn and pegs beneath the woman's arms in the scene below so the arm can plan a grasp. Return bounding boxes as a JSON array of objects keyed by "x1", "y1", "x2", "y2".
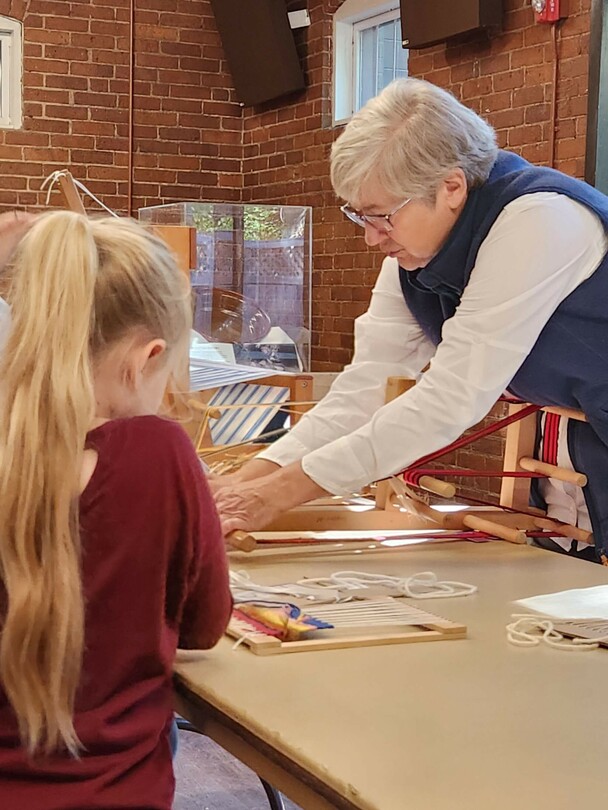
[{"x1": 221, "y1": 377, "x2": 593, "y2": 558}]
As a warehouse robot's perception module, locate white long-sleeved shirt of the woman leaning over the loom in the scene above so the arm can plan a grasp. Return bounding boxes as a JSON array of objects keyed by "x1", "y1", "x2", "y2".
[{"x1": 260, "y1": 192, "x2": 608, "y2": 495}]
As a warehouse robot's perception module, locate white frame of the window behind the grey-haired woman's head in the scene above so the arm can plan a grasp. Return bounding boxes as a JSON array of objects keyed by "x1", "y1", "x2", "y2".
[{"x1": 332, "y1": 0, "x2": 401, "y2": 126}]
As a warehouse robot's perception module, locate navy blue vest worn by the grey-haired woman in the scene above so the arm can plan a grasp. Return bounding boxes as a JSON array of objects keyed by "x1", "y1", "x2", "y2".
[{"x1": 399, "y1": 151, "x2": 608, "y2": 446}]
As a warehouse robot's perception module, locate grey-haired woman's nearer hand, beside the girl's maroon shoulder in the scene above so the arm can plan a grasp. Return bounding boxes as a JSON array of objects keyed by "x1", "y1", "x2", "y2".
[{"x1": 214, "y1": 462, "x2": 327, "y2": 535}]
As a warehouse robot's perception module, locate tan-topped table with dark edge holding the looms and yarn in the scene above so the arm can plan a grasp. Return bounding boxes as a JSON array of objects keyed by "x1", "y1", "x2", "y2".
[{"x1": 177, "y1": 542, "x2": 608, "y2": 810}]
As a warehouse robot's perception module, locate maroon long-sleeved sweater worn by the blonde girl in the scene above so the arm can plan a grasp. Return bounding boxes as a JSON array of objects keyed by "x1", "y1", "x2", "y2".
[{"x1": 0, "y1": 416, "x2": 231, "y2": 810}]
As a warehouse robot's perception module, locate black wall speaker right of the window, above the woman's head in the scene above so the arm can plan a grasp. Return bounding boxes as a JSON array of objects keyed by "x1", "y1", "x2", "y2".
[{"x1": 401, "y1": 0, "x2": 503, "y2": 48}]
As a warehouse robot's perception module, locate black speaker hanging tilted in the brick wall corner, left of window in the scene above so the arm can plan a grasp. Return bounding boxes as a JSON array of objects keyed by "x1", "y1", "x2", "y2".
[{"x1": 211, "y1": 0, "x2": 305, "y2": 104}]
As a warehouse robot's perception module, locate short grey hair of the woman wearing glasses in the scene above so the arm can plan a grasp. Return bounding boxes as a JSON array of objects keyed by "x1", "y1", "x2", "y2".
[{"x1": 331, "y1": 79, "x2": 498, "y2": 206}]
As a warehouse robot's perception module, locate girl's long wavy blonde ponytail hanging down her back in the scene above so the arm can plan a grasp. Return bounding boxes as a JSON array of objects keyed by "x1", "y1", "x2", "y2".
[{"x1": 0, "y1": 213, "x2": 97, "y2": 753}]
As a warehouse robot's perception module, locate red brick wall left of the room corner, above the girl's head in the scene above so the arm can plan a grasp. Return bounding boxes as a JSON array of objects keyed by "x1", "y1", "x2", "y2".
[{"x1": 0, "y1": 0, "x2": 242, "y2": 213}]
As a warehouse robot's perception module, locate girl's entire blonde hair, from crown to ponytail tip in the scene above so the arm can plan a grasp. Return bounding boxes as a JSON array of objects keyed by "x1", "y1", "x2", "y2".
[{"x1": 0, "y1": 211, "x2": 190, "y2": 755}]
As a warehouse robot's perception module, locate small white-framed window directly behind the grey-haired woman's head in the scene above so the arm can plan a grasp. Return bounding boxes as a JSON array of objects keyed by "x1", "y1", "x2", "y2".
[{"x1": 333, "y1": 0, "x2": 408, "y2": 124}]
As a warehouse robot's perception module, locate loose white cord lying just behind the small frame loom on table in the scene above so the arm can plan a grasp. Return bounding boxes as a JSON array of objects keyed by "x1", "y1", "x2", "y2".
[{"x1": 298, "y1": 571, "x2": 477, "y2": 599}]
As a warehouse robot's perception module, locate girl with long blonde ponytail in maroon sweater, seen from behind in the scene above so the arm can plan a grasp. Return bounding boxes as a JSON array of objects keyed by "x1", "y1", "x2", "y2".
[{"x1": 0, "y1": 211, "x2": 231, "y2": 810}]
